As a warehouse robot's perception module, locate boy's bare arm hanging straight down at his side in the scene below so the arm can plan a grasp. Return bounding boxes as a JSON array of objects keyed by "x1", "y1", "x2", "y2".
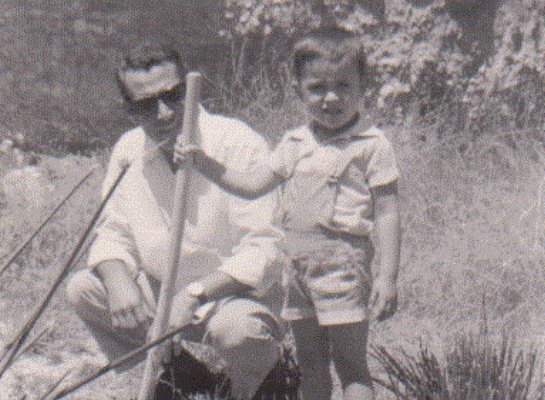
[{"x1": 370, "y1": 182, "x2": 401, "y2": 321}]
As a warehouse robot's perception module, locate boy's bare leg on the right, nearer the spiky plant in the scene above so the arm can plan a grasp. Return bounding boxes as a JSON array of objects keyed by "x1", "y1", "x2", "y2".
[{"x1": 328, "y1": 321, "x2": 375, "y2": 400}]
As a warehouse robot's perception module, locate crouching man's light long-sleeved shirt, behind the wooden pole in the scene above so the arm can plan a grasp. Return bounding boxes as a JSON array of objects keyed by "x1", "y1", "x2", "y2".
[{"x1": 88, "y1": 108, "x2": 281, "y2": 295}]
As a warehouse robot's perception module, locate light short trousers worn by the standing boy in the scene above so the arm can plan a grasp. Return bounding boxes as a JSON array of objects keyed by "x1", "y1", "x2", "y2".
[{"x1": 281, "y1": 233, "x2": 373, "y2": 325}]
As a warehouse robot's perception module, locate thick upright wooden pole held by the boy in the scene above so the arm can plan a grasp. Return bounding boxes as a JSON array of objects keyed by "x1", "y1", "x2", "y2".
[{"x1": 138, "y1": 72, "x2": 202, "y2": 400}]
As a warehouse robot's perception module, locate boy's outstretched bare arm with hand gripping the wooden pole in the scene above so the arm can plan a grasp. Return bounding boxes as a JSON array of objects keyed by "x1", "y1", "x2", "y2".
[{"x1": 174, "y1": 145, "x2": 283, "y2": 199}]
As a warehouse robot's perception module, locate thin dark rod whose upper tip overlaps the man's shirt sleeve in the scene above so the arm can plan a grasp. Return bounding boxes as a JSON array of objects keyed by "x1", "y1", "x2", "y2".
[{"x1": 0, "y1": 165, "x2": 129, "y2": 378}]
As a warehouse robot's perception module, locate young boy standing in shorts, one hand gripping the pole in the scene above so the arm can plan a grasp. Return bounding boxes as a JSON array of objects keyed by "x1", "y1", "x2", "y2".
[{"x1": 175, "y1": 28, "x2": 400, "y2": 400}]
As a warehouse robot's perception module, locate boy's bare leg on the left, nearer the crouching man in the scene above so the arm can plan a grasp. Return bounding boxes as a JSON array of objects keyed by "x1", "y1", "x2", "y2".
[{"x1": 291, "y1": 318, "x2": 332, "y2": 400}]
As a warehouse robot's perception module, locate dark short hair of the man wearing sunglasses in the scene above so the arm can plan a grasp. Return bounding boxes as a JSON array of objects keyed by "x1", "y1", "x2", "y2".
[{"x1": 115, "y1": 41, "x2": 184, "y2": 103}]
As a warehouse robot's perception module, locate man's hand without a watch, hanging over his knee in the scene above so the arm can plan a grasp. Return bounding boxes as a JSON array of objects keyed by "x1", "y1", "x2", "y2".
[{"x1": 97, "y1": 260, "x2": 154, "y2": 329}]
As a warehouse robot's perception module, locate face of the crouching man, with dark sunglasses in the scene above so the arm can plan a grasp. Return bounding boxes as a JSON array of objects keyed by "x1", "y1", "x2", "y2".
[{"x1": 121, "y1": 61, "x2": 184, "y2": 148}]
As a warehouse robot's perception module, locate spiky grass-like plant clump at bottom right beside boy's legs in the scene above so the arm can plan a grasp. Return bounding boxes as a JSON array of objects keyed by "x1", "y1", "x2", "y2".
[{"x1": 371, "y1": 335, "x2": 539, "y2": 400}]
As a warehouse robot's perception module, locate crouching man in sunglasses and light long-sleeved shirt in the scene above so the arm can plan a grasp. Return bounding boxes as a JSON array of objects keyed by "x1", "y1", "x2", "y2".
[{"x1": 67, "y1": 43, "x2": 282, "y2": 398}]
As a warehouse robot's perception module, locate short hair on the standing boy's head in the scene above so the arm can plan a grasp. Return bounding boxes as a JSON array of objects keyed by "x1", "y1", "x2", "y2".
[{"x1": 292, "y1": 26, "x2": 367, "y2": 83}]
